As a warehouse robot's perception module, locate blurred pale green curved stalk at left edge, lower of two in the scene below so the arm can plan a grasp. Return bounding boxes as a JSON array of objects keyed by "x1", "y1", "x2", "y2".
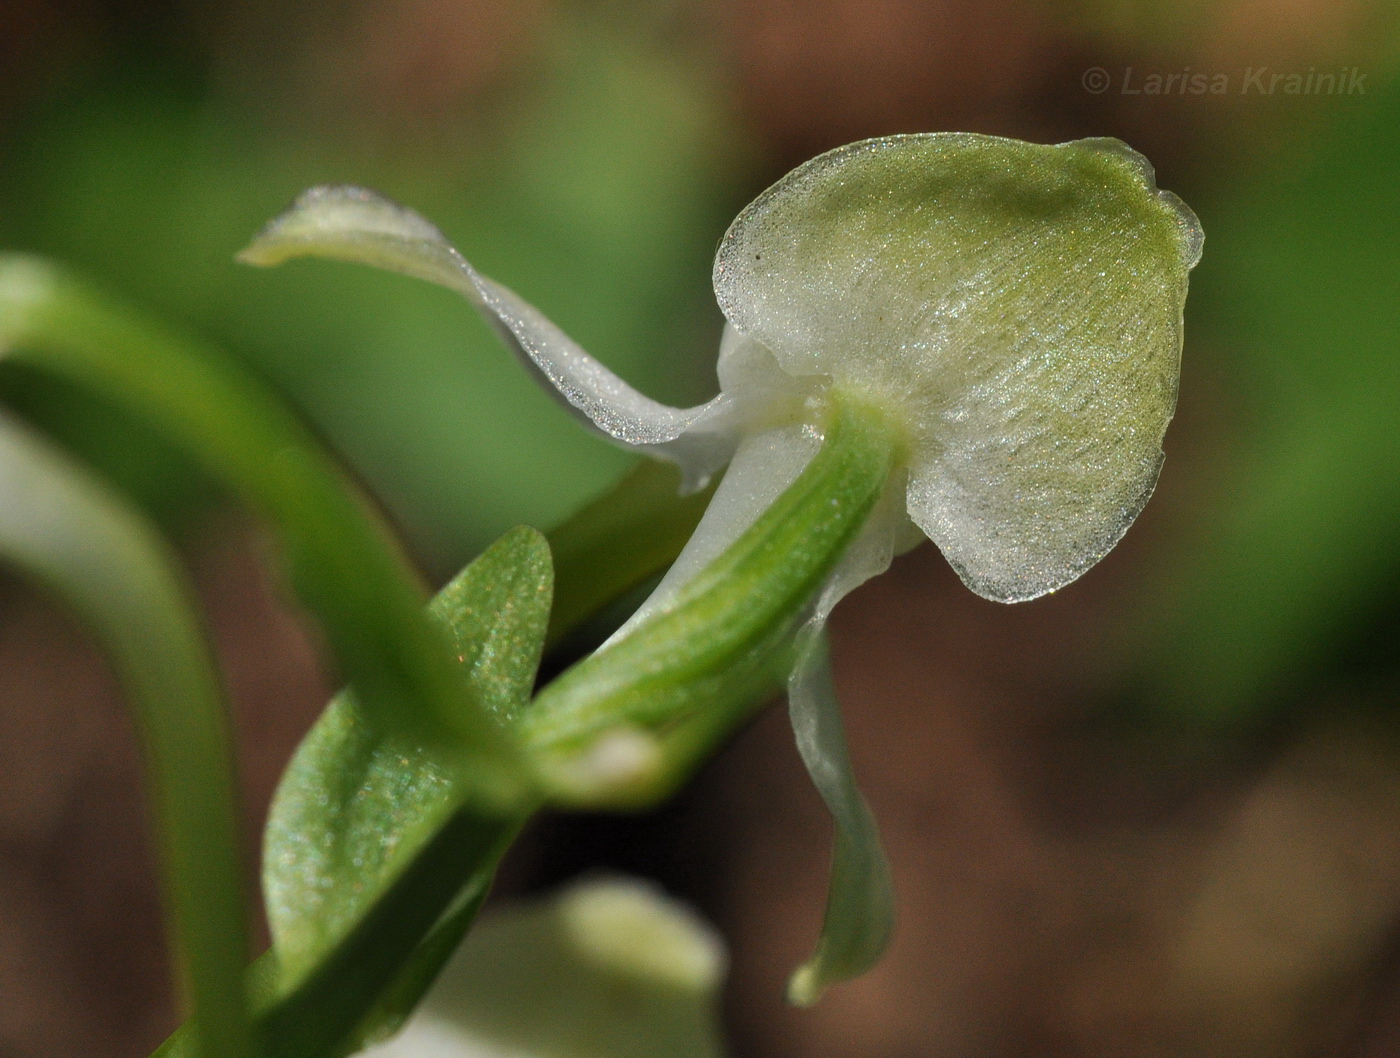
[{"x1": 0, "y1": 417, "x2": 252, "y2": 1058}]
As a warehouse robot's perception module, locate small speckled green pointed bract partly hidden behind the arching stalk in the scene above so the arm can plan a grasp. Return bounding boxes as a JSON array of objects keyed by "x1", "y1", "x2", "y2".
[{"x1": 263, "y1": 528, "x2": 552, "y2": 985}]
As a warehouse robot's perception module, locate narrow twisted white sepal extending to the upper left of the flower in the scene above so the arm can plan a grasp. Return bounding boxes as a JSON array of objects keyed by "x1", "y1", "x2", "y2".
[{"x1": 238, "y1": 185, "x2": 736, "y2": 488}]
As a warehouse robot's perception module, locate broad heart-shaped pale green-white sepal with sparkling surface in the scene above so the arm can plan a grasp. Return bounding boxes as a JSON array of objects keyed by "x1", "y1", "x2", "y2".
[{"x1": 714, "y1": 133, "x2": 1201, "y2": 602}]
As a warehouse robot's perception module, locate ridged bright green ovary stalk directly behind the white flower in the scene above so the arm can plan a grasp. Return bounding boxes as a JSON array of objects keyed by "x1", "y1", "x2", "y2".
[{"x1": 519, "y1": 399, "x2": 899, "y2": 803}]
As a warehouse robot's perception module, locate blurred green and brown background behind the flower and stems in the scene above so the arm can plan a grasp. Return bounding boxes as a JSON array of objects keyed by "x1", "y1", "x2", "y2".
[{"x1": 0, "y1": 0, "x2": 1400, "y2": 1058}]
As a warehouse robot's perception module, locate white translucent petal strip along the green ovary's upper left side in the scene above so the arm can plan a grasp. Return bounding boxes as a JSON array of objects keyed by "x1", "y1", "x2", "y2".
[{"x1": 605, "y1": 425, "x2": 822, "y2": 645}]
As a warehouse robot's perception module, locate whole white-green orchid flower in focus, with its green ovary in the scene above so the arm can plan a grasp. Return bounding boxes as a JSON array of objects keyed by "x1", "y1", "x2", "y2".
[{"x1": 241, "y1": 133, "x2": 1201, "y2": 1003}]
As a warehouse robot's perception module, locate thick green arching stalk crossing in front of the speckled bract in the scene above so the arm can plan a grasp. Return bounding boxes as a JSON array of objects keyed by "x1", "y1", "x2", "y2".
[{"x1": 0, "y1": 255, "x2": 522, "y2": 803}]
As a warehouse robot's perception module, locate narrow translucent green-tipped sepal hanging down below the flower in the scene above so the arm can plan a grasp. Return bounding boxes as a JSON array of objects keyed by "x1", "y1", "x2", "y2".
[{"x1": 788, "y1": 623, "x2": 895, "y2": 1006}]
